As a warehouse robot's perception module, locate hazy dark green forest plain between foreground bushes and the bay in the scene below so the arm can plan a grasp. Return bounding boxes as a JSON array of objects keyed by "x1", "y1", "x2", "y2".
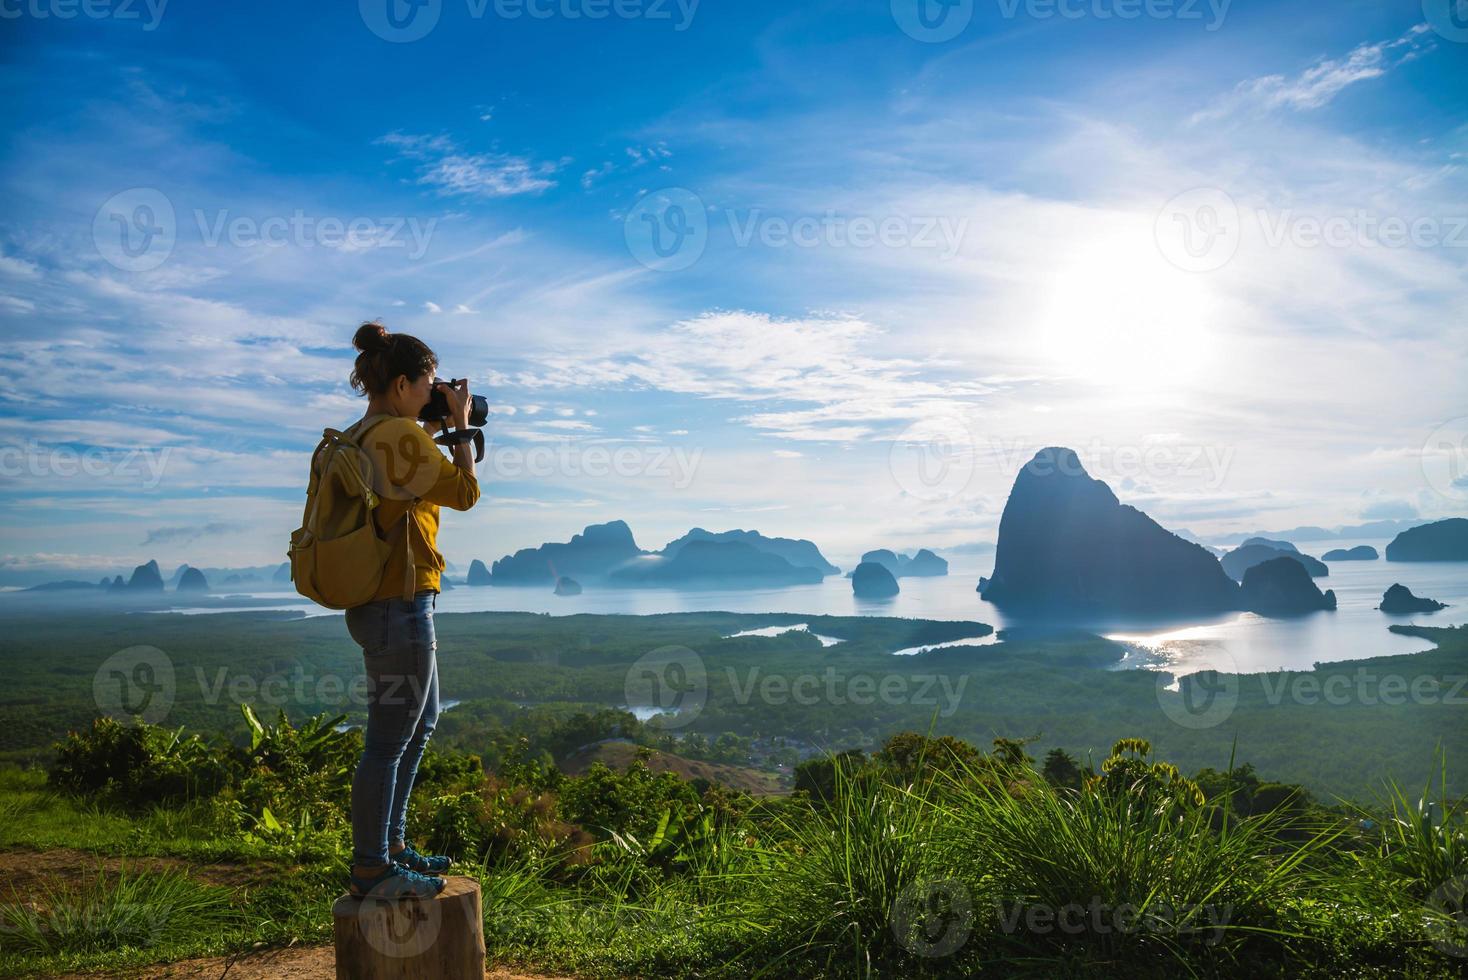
[{"x1": 0, "y1": 612, "x2": 1468, "y2": 798}]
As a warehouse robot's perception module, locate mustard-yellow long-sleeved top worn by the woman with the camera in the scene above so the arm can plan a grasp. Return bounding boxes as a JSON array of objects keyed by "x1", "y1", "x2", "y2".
[{"x1": 350, "y1": 415, "x2": 479, "y2": 601}]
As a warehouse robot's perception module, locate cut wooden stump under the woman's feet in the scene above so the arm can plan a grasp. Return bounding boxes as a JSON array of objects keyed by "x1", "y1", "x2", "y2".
[{"x1": 332, "y1": 877, "x2": 484, "y2": 980}]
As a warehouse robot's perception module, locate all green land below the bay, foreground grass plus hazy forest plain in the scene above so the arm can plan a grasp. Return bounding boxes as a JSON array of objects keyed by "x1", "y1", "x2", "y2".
[{"x1": 0, "y1": 613, "x2": 1468, "y2": 977}]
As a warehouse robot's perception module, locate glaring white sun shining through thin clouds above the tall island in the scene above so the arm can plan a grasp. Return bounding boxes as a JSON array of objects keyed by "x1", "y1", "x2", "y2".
[{"x1": 1033, "y1": 235, "x2": 1217, "y2": 392}]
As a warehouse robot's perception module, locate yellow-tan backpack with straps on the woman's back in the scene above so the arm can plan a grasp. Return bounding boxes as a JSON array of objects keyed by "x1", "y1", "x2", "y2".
[{"x1": 286, "y1": 415, "x2": 417, "y2": 609}]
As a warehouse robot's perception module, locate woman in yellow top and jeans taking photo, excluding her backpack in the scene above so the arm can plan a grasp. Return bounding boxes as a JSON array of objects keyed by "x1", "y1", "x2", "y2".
[{"x1": 346, "y1": 323, "x2": 479, "y2": 898}]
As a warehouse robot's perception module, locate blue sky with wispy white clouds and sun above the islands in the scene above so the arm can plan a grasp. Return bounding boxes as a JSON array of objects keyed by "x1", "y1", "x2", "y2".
[{"x1": 0, "y1": 0, "x2": 1468, "y2": 578}]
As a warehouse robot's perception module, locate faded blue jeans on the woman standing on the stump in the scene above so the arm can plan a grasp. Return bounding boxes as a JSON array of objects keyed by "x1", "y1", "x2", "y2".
[{"x1": 346, "y1": 590, "x2": 439, "y2": 867}]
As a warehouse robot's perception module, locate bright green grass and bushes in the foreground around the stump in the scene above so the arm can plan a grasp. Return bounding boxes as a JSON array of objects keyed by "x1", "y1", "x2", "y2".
[{"x1": 0, "y1": 710, "x2": 1468, "y2": 977}]
